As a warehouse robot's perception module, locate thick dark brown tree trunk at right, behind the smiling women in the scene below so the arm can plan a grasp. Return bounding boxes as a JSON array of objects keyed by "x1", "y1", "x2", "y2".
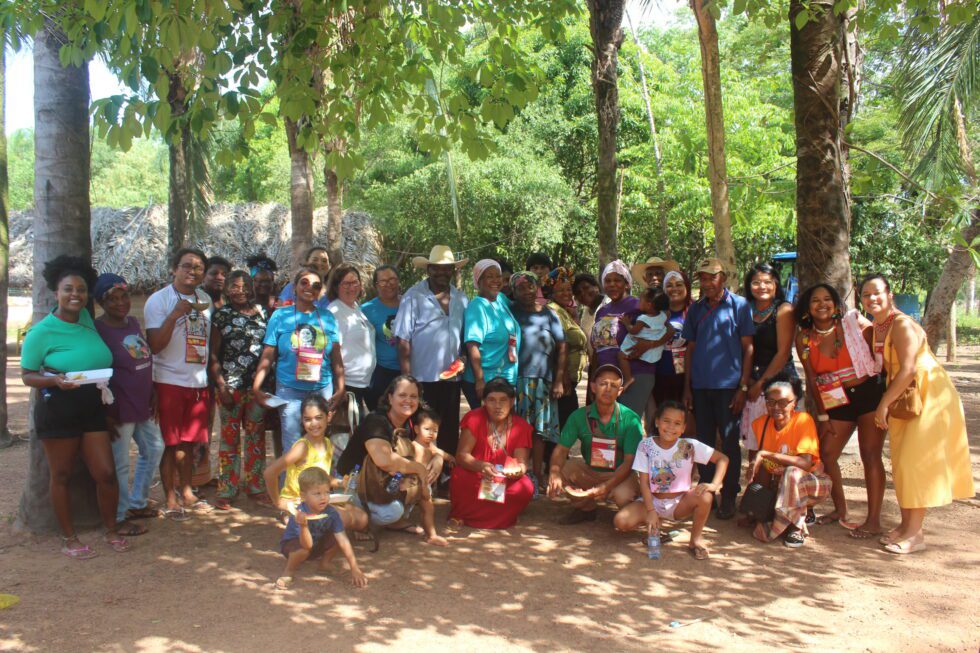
[{"x1": 789, "y1": 0, "x2": 854, "y2": 305}]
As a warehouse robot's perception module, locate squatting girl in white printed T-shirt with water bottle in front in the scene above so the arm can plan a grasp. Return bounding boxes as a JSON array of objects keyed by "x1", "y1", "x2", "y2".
[{"x1": 614, "y1": 401, "x2": 728, "y2": 560}]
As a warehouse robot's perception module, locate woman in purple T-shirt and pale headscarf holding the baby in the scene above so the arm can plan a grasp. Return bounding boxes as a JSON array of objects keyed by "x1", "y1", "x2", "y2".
[{"x1": 589, "y1": 259, "x2": 657, "y2": 415}]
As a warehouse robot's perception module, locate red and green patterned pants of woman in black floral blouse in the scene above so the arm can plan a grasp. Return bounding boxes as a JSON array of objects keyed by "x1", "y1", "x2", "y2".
[{"x1": 218, "y1": 389, "x2": 265, "y2": 499}]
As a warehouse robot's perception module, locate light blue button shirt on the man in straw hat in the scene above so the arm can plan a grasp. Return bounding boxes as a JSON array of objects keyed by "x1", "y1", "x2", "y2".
[{"x1": 392, "y1": 279, "x2": 467, "y2": 383}]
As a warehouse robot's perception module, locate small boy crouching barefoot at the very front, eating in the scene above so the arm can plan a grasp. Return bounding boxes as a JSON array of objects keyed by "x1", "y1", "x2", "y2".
[{"x1": 276, "y1": 467, "x2": 367, "y2": 590}]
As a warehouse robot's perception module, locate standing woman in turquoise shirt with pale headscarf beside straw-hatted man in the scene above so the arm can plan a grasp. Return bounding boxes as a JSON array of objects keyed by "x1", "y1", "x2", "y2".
[{"x1": 463, "y1": 258, "x2": 521, "y2": 409}]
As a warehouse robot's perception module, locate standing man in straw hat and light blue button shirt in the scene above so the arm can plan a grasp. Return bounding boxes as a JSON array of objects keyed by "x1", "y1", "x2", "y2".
[{"x1": 392, "y1": 245, "x2": 467, "y2": 453}]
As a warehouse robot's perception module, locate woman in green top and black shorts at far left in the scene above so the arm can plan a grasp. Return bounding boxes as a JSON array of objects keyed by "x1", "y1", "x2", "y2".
[{"x1": 20, "y1": 255, "x2": 138, "y2": 560}]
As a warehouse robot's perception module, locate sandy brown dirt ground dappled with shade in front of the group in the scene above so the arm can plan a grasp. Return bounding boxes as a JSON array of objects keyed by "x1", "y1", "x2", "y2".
[{"x1": 0, "y1": 351, "x2": 980, "y2": 653}]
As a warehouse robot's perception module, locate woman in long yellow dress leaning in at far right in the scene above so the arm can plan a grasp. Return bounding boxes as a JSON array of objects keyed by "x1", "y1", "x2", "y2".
[{"x1": 860, "y1": 274, "x2": 974, "y2": 554}]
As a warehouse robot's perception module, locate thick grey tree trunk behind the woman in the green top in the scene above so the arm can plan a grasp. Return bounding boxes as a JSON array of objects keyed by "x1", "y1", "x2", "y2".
[{"x1": 17, "y1": 22, "x2": 99, "y2": 532}]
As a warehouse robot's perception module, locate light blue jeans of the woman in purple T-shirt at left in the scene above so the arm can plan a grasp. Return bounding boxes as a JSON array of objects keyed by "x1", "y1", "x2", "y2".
[{"x1": 112, "y1": 419, "x2": 163, "y2": 521}]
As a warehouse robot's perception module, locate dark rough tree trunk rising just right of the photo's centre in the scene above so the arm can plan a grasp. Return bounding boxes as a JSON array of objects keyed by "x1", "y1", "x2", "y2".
[{"x1": 586, "y1": 0, "x2": 626, "y2": 266}]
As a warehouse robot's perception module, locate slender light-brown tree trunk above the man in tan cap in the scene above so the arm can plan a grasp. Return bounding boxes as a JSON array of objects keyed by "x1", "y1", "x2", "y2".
[{"x1": 691, "y1": 0, "x2": 738, "y2": 278}]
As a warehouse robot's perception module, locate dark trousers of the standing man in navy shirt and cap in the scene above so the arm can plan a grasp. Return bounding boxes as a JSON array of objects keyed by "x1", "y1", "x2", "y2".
[{"x1": 691, "y1": 388, "x2": 742, "y2": 499}]
